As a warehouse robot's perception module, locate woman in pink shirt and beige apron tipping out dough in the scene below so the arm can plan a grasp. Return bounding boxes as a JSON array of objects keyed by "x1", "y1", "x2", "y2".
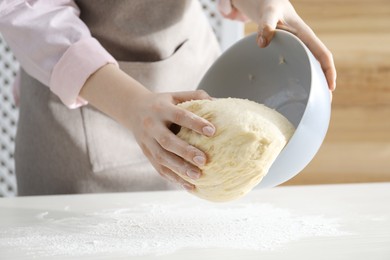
[{"x1": 0, "y1": 0, "x2": 336, "y2": 195}]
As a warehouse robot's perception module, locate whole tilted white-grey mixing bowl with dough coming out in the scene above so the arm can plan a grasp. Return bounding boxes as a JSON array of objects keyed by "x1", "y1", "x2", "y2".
[{"x1": 198, "y1": 30, "x2": 331, "y2": 188}]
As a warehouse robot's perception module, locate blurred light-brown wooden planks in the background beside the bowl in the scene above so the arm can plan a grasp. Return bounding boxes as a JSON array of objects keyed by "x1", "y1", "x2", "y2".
[{"x1": 246, "y1": 0, "x2": 390, "y2": 184}]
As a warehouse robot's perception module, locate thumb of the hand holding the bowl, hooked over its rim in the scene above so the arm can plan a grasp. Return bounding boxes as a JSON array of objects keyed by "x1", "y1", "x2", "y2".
[{"x1": 257, "y1": 5, "x2": 280, "y2": 48}]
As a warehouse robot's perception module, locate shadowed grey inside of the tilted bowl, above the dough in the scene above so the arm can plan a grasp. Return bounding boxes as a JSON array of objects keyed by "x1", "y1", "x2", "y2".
[{"x1": 198, "y1": 31, "x2": 311, "y2": 127}]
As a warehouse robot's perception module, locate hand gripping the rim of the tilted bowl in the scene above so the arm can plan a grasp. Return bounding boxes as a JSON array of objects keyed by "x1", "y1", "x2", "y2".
[{"x1": 227, "y1": 0, "x2": 336, "y2": 91}]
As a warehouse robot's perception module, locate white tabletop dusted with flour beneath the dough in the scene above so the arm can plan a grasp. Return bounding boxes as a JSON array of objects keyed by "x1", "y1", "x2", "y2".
[{"x1": 0, "y1": 183, "x2": 390, "y2": 260}]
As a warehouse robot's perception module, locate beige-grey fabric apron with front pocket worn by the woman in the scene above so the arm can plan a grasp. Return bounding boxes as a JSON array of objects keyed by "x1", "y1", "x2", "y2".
[{"x1": 15, "y1": 0, "x2": 219, "y2": 195}]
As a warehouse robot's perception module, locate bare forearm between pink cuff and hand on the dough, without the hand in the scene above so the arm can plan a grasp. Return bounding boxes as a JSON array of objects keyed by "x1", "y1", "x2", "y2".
[{"x1": 80, "y1": 64, "x2": 151, "y2": 129}]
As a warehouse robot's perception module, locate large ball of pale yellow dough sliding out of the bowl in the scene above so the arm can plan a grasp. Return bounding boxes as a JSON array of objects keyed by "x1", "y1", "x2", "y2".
[{"x1": 178, "y1": 98, "x2": 295, "y2": 202}]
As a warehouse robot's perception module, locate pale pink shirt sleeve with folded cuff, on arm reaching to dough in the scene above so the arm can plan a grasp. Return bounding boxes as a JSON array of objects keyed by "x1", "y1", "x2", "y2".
[{"x1": 0, "y1": 0, "x2": 118, "y2": 108}]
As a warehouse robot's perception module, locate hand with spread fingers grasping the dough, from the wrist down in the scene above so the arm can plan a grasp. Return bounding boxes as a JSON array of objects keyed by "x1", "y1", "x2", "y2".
[{"x1": 130, "y1": 90, "x2": 215, "y2": 191}]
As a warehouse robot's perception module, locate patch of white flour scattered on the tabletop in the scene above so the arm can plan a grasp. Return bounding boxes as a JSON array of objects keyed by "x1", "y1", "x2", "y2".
[{"x1": 0, "y1": 203, "x2": 346, "y2": 256}]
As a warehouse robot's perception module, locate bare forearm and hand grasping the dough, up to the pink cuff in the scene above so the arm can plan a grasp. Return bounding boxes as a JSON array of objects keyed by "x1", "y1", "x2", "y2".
[{"x1": 80, "y1": 64, "x2": 215, "y2": 191}]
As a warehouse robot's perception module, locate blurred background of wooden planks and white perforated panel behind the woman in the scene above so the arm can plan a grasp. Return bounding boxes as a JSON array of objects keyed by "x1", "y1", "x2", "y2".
[{"x1": 0, "y1": 0, "x2": 390, "y2": 197}]
